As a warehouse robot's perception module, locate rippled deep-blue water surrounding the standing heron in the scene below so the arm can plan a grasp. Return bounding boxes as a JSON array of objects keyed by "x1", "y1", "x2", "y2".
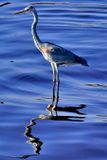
[{"x1": 0, "y1": 0, "x2": 107, "y2": 160}]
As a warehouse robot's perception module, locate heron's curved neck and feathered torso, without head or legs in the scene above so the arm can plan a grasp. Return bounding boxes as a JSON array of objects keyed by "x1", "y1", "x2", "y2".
[{"x1": 31, "y1": 8, "x2": 87, "y2": 65}]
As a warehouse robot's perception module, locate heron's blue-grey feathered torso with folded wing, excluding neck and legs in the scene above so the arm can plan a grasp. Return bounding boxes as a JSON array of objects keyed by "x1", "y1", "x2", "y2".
[{"x1": 39, "y1": 42, "x2": 86, "y2": 65}]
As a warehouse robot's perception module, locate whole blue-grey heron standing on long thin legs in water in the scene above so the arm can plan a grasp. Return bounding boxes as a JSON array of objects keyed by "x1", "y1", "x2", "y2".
[{"x1": 15, "y1": 5, "x2": 88, "y2": 110}]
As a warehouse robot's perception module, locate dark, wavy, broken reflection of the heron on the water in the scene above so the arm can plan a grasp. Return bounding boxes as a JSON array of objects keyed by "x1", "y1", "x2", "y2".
[{"x1": 23, "y1": 104, "x2": 86, "y2": 158}]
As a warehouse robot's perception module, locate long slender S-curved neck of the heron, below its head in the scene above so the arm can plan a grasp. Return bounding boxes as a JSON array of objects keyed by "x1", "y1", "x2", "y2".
[{"x1": 32, "y1": 11, "x2": 42, "y2": 50}]
